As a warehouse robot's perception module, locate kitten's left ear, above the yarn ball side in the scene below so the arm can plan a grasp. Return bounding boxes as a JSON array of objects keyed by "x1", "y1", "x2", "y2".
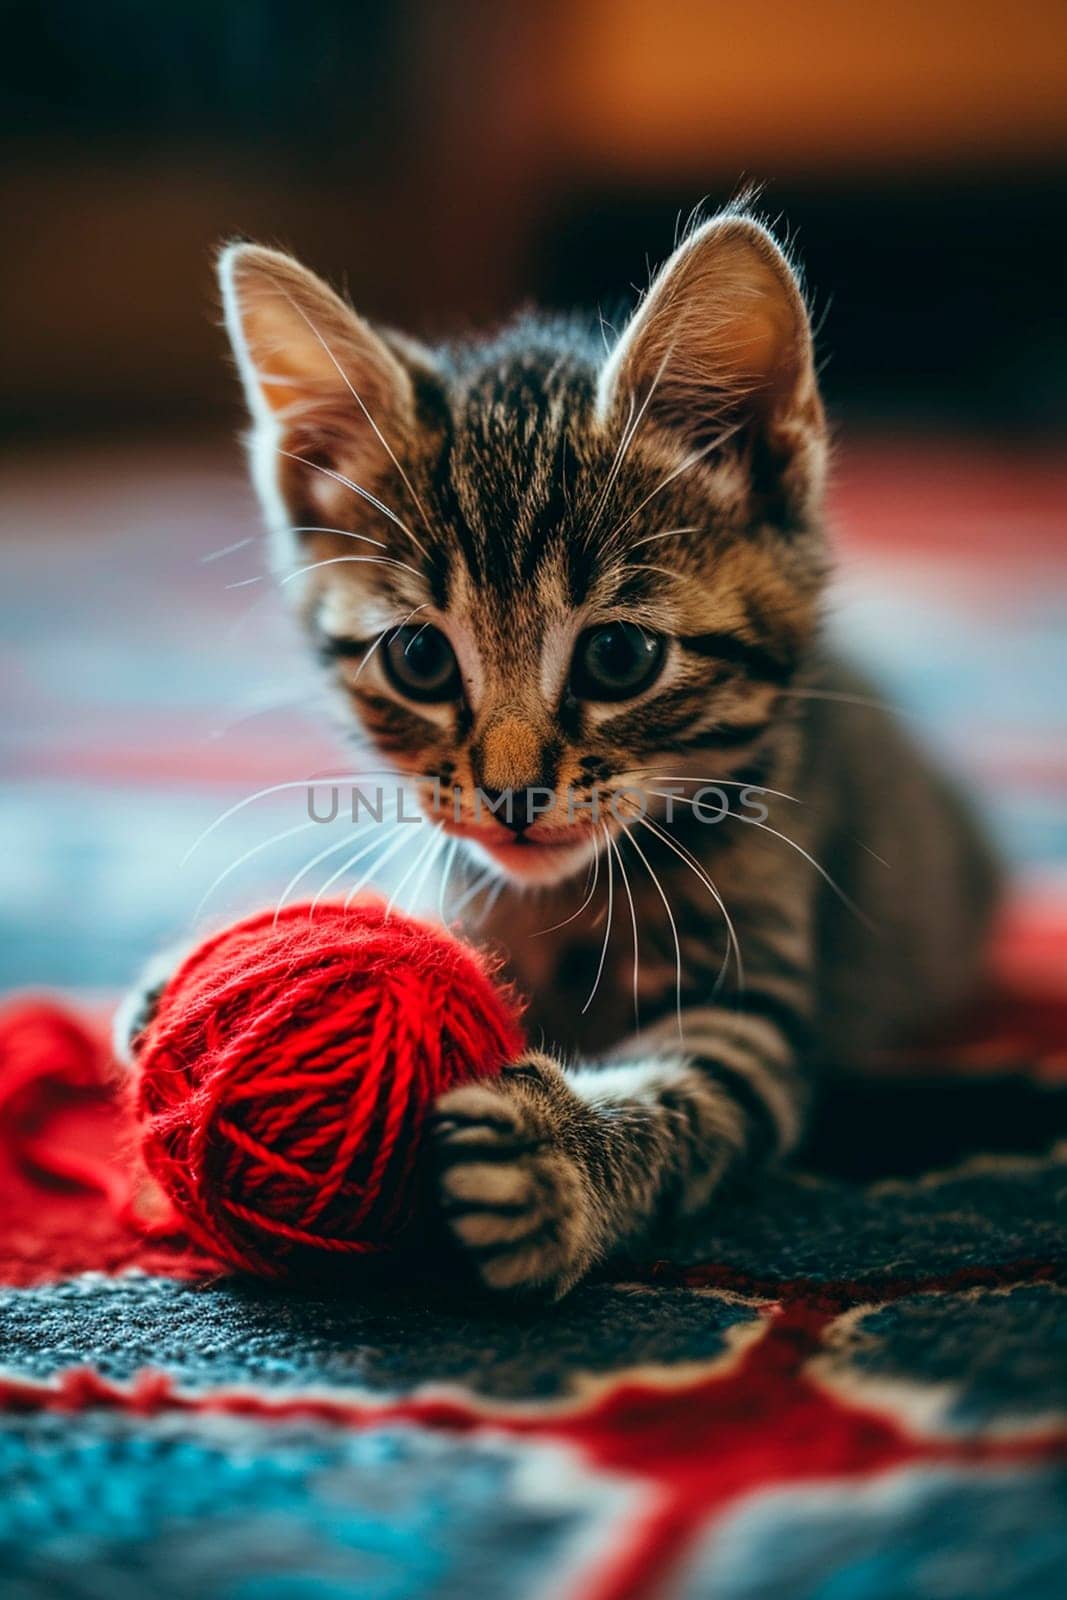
[{"x1": 219, "y1": 245, "x2": 414, "y2": 514}]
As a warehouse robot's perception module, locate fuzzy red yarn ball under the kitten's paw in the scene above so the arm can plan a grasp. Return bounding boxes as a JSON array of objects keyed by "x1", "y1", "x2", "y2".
[{"x1": 138, "y1": 902, "x2": 523, "y2": 1277}]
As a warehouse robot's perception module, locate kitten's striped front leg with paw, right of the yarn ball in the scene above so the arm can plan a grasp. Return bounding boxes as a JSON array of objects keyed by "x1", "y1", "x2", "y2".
[{"x1": 437, "y1": 1008, "x2": 803, "y2": 1298}]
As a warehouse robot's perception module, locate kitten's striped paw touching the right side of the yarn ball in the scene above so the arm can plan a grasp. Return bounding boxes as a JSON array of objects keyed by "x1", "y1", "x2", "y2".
[{"x1": 434, "y1": 1053, "x2": 600, "y2": 1299}]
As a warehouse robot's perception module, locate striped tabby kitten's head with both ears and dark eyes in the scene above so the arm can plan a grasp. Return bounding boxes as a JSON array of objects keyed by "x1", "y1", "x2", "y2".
[{"x1": 221, "y1": 213, "x2": 825, "y2": 883}]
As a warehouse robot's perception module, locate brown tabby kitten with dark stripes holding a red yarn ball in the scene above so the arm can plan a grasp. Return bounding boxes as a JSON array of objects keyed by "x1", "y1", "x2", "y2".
[{"x1": 127, "y1": 208, "x2": 993, "y2": 1294}]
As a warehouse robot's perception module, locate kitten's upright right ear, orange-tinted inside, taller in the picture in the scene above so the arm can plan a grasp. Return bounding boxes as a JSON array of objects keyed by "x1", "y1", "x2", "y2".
[{"x1": 598, "y1": 214, "x2": 825, "y2": 510}]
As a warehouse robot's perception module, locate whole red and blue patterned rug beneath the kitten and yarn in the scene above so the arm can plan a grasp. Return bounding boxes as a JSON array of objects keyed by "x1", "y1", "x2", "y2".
[{"x1": 0, "y1": 450, "x2": 1067, "y2": 1600}]
